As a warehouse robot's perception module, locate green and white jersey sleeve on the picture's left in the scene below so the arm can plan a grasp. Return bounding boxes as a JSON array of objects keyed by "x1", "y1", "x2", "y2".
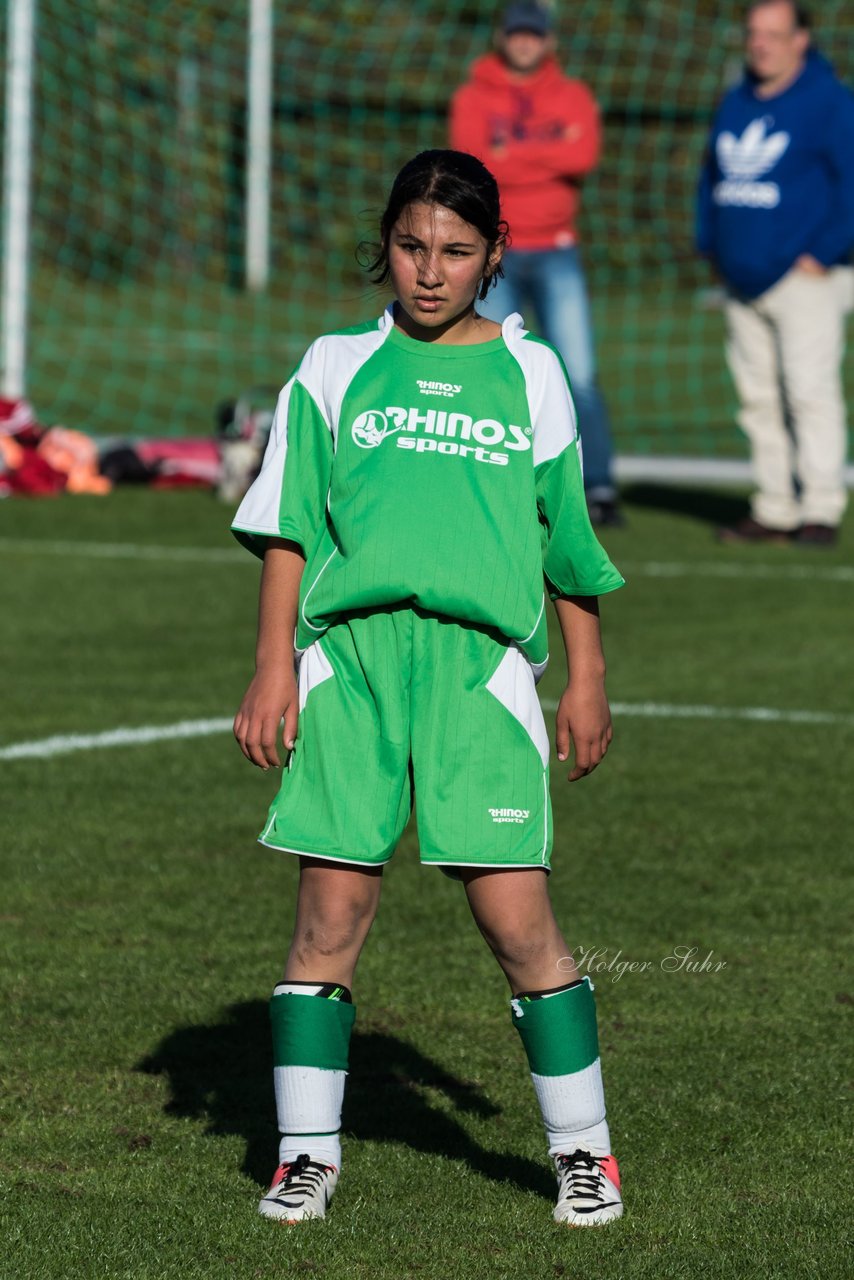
[{"x1": 232, "y1": 372, "x2": 333, "y2": 558}]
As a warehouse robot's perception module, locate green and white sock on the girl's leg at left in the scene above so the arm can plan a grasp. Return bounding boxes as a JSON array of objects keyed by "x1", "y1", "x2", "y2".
[{"x1": 270, "y1": 982, "x2": 356, "y2": 1169}]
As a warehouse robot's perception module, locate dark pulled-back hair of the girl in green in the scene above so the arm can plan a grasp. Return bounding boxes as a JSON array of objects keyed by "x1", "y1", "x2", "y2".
[{"x1": 366, "y1": 151, "x2": 510, "y2": 298}]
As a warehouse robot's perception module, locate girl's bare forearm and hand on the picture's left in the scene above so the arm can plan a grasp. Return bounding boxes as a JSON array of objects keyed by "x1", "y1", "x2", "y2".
[{"x1": 234, "y1": 538, "x2": 306, "y2": 769}]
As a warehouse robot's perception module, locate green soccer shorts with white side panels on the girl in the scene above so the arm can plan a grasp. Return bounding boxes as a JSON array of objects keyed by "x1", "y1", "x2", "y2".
[{"x1": 259, "y1": 609, "x2": 552, "y2": 874}]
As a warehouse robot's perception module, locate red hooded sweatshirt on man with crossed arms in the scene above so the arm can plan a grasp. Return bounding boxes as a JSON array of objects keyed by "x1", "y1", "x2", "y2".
[{"x1": 451, "y1": 54, "x2": 602, "y2": 250}]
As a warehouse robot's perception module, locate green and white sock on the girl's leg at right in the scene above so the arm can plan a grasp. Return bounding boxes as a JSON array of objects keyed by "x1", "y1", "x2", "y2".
[{"x1": 511, "y1": 978, "x2": 611, "y2": 1156}]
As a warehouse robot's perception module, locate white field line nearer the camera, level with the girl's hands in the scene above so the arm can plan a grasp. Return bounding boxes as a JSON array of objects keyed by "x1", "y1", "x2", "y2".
[{"x1": 0, "y1": 698, "x2": 854, "y2": 760}]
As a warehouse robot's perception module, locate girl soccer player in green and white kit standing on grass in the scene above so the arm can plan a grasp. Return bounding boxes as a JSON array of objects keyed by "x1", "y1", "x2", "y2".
[{"x1": 233, "y1": 151, "x2": 622, "y2": 1226}]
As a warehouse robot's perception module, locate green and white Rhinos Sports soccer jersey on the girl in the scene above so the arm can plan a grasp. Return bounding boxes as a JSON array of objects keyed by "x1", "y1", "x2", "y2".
[{"x1": 232, "y1": 308, "x2": 624, "y2": 664}]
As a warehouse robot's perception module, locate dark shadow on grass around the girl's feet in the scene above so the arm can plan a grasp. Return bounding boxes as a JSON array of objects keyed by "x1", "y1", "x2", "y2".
[{"x1": 136, "y1": 1000, "x2": 553, "y2": 1198}]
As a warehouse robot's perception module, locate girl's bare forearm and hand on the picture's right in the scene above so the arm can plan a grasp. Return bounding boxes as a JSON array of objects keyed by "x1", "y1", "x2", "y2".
[{"x1": 554, "y1": 595, "x2": 613, "y2": 782}]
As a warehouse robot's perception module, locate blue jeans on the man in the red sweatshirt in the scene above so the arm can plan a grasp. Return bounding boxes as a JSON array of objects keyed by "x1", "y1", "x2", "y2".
[{"x1": 478, "y1": 248, "x2": 616, "y2": 500}]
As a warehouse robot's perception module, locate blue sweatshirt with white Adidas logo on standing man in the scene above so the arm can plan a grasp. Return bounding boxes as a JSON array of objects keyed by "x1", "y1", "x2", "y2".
[{"x1": 697, "y1": 50, "x2": 854, "y2": 297}]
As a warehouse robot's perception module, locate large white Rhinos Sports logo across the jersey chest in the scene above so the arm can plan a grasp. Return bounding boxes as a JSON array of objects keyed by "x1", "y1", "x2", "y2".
[{"x1": 350, "y1": 404, "x2": 531, "y2": 467}]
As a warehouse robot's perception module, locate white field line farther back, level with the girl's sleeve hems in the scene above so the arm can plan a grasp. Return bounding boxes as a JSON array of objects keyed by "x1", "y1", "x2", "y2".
[{"x1": 0, "y1": 538, "x2": 854, "y2": 582}]
